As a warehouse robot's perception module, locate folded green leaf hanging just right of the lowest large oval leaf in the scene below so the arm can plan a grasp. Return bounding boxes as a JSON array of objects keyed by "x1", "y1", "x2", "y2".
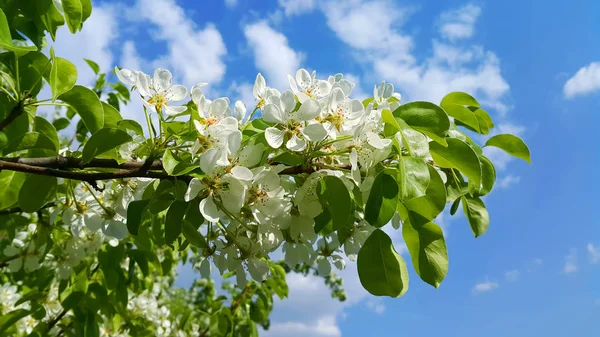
[{"x1": 402, "y1": 212, "x2": 448, "y2": 288}]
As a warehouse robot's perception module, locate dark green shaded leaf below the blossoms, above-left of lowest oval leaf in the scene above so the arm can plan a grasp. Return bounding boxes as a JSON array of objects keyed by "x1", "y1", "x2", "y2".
[{"x1": 317, "y1": 176, "x2": 354, "y2": 230}]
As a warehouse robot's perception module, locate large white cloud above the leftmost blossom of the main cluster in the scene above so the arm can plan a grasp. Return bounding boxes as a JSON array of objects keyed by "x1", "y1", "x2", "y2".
[{"x1": 127, "y1": 0, "x2": 227, "y2": 86}]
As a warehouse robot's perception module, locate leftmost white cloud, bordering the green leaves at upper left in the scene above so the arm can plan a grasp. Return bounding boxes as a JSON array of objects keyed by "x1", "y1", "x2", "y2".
[{"x1": 48, "y1": 5, "x2": 118, "y2": 85}]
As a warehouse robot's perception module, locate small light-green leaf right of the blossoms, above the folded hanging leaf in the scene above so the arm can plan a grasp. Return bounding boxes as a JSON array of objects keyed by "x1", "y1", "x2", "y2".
[{"x1": 398, "y1": 157, "x2": 429, "y2": 200}]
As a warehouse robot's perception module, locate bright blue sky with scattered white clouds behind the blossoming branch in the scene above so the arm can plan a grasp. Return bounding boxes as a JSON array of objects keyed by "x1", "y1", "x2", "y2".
[{"x1": 50, "y1": 0, "x2": 600, "y2": 337}]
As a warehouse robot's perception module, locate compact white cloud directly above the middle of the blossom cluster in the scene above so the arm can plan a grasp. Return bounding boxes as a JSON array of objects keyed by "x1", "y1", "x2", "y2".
[{"x1": 244, "y1": 21, "x2": 304, "y2": 89}]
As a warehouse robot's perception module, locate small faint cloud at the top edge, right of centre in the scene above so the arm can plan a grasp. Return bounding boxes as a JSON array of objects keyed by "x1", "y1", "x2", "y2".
[{"x1": 440, "y1": 4, "x2": 481, "y2": 40}]
